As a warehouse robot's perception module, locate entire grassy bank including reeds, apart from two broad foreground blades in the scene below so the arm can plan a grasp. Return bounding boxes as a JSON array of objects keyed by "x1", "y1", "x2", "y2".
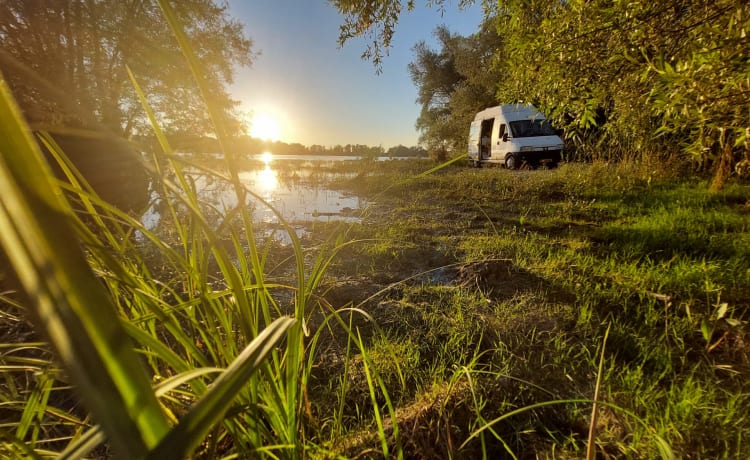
[{"x1": 0, "y1": 143, "x2": 750, "y2": 458}]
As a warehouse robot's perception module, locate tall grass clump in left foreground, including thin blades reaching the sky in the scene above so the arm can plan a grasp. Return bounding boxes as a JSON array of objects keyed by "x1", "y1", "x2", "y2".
[{"x1": 0, "y1": 2, "x2": 358, "y2": 458}]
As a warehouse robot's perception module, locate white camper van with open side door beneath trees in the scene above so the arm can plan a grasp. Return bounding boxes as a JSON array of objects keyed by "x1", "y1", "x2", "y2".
[{"x1": 469, "y1": 104, "x2": 563, "y2": 169}]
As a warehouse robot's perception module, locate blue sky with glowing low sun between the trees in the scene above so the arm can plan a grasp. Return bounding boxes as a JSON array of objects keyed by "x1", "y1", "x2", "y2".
[{"x1": 229, "y1": 0, "x2": 482, "y2": 150}]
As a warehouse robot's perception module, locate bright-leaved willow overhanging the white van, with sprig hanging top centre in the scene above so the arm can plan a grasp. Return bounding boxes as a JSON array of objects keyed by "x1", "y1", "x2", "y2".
[{"x1": 332, "y1": 0, "x2": 750, "y2": 189}]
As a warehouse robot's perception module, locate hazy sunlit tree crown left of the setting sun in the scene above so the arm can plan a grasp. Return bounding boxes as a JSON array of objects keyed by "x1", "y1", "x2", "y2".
[{"x1": 0, "y1": 0, "x2": 252, "y2": 136}]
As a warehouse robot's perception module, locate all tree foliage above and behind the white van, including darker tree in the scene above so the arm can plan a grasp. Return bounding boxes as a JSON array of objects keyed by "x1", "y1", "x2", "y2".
[{"x1": 339, "y1": 0, "x2": 750, "y2": 187}]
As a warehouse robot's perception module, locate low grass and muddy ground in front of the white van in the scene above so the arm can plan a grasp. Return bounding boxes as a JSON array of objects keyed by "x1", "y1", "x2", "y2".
[{"x1": 314, "y1": 160, "x2": 750, "y2": 458}]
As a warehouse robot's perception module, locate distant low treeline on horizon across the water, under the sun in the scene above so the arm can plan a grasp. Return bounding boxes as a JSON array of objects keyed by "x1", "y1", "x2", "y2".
[{"x1": 136, "y1": 135, "x2": 427, "y2": 157}]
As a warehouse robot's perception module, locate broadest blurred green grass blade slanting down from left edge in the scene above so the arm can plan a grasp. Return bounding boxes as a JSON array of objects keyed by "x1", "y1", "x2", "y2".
[{"x1": 0, "y1": 79, "x2": 169, "y2": 458}]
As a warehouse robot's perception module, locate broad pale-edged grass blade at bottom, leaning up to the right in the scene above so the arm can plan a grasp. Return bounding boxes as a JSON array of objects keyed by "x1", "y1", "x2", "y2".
[{"x1": 149, "y1": 317, "x2": 296, "y2": 460}]
